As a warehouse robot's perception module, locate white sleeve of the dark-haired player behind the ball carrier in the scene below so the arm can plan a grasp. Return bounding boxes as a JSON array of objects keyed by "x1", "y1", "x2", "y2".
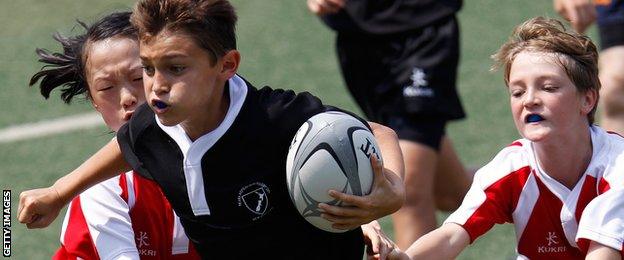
[{"x1": 80, "y1": 176, "x2": 139, "y2": 259}]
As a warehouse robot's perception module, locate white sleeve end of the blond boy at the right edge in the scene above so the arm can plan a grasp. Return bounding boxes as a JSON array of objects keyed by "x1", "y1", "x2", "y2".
[{"x1": 576, "y1": 189, "x2": 624, "y2": 251}]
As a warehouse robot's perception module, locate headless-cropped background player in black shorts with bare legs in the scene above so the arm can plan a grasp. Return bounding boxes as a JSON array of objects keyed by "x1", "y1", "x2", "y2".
[{"x1": 307, "y1": 0, "x2": 473, "y2": 248}]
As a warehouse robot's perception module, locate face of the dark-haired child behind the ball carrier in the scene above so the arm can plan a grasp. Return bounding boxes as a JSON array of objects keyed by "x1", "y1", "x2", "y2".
[{"x1": 85, "y1": 37, "x2": 145, "y2": 131}]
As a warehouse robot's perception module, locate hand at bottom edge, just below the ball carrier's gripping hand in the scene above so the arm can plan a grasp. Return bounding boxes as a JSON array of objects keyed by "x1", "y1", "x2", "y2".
[{"x1": 362, "y1": 220, "x2": 397, "y2": 259}]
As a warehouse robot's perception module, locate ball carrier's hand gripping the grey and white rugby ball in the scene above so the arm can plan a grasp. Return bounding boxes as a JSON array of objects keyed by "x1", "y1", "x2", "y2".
[{"x1": 319, "y1": 156, "x2": 405, "y2": 229}]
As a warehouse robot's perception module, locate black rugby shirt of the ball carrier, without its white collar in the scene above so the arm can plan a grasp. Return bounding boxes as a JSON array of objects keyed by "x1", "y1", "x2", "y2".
[{"x1": 117, "y1": 78, "x2": 363, "y2": 259}]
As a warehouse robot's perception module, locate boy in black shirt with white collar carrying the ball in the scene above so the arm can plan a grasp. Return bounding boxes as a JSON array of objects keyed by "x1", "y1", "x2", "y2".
[{"x1": 18, "y1": 0, "x2": 404, "y2": 259}]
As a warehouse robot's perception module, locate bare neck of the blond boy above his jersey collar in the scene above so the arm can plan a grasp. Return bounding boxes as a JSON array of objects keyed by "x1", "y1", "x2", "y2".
[{"x1": 534, "y1": 126, "x2": 593, "y2": 190}]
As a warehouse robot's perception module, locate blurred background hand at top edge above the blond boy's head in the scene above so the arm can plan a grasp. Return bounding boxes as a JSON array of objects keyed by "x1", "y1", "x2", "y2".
[{"x1": 553, "y1": 0, "x2": 596, "y2": 33}]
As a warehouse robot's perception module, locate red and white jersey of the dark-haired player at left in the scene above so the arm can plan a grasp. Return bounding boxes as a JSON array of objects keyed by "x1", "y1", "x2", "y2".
[{"x1": 52, "y1": 172, "x2": 200, "y2": 259}]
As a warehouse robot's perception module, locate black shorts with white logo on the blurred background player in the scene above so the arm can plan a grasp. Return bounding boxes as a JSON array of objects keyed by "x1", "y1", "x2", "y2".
[{"x1": 336, "y1": 16, "x2": 465, "y2": 150}]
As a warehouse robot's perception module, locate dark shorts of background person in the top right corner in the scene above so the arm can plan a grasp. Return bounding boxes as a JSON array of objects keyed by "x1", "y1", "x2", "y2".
[{"x1": 596, "y1": 0, "x2": 624, "y2": 50}]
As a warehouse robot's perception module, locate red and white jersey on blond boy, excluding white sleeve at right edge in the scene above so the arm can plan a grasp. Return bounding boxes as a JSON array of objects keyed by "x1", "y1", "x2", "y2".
[{"x1": 445, "y1": 126, "x2": 624, "y2": 259}]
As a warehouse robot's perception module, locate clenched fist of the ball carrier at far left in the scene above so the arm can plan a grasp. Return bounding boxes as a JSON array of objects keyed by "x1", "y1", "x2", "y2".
[{"x1": 17, "y1": 187, "x2": 65, "y2": 229}]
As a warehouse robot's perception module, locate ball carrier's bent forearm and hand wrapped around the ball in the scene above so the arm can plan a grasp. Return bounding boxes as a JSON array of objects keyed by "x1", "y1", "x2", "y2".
[{"x1": 319, "y1": 122, "x2": 405, "y2": 229}]
